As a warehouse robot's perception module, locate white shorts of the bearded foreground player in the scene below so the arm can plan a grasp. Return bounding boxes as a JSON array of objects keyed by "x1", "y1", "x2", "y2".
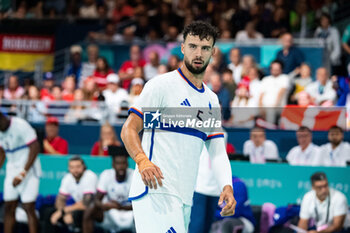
[{"x1": 132, "y1": 193, "x2": 191, "y2": 233}]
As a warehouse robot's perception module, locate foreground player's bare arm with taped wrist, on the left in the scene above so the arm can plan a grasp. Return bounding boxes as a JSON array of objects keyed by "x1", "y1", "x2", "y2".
[{"x1": 121, "y1": 113, "x2": 164, "y2": 189}]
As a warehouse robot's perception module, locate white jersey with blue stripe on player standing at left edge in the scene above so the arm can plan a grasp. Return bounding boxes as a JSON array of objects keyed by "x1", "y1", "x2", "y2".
[{"x1": 0, "y1": 117, "x2": 41, "y2": 176}]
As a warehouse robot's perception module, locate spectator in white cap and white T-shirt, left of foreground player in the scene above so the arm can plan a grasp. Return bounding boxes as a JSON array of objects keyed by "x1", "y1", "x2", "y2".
[{"x1": 102, "y1": 73, "x2": 129, "y2": 123}]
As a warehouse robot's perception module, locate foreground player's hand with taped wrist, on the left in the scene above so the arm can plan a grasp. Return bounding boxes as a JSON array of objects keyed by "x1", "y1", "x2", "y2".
[{"x1": 135, "y1": 153, "x2": 164, "y2": 189}]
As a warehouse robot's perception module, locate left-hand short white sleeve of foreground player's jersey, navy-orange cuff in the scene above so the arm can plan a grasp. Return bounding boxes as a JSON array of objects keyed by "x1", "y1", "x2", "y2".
[{"x1": 129, "y1": 78, "x2": 162, "y2": 119}]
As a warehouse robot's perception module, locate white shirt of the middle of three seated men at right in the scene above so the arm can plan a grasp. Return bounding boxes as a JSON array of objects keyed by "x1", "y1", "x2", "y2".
[{"x1": 286, "y1": 143, "x2": 322, "y2": 166}]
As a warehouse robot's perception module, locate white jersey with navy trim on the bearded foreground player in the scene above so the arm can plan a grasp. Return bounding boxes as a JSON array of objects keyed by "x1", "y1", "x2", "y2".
[{"x1": 129, "y1": 69, "x2": 224, "y2": 205}]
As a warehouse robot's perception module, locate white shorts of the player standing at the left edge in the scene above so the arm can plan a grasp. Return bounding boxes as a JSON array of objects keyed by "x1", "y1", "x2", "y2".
[{"x1": 4, "y1": 172, "x2": 39, "y2": 203}]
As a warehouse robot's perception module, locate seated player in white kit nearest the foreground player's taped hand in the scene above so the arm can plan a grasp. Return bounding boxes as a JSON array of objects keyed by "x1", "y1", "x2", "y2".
[{"x1": 83, "y1": 154, "x2": 135, "y2": 233}]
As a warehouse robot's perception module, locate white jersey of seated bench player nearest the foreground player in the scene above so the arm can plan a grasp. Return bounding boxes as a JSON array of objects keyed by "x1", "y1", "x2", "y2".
[{"x1": 97, "y1": 168, "x2": 134, "y2": 204}]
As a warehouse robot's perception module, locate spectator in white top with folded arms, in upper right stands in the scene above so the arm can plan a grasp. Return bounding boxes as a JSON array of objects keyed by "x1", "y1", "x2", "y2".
[{"x1": 306, "y1": 67, "x2": 336, "y2": 106}]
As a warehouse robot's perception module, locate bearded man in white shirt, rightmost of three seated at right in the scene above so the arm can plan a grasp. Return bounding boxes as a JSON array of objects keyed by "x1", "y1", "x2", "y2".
[{"x1": 319, "y1": 126, "x2": 350, "y2": 167}]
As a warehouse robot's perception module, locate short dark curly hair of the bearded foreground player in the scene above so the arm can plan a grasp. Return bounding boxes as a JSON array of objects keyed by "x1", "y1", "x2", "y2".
[{"x1": 182, "y1": 21, "x2": 219, "y2": 46}]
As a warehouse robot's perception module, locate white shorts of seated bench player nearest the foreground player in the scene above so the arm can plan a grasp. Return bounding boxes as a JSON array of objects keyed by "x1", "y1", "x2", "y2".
[{"x1": 100, "y1": 209, "x2": 135, "y2": 231}]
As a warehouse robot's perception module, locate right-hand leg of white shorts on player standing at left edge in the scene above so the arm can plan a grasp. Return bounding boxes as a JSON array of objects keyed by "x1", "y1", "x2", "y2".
[{"x1": 19, "y1": 174, "x2": 40, "y2": 203}]
